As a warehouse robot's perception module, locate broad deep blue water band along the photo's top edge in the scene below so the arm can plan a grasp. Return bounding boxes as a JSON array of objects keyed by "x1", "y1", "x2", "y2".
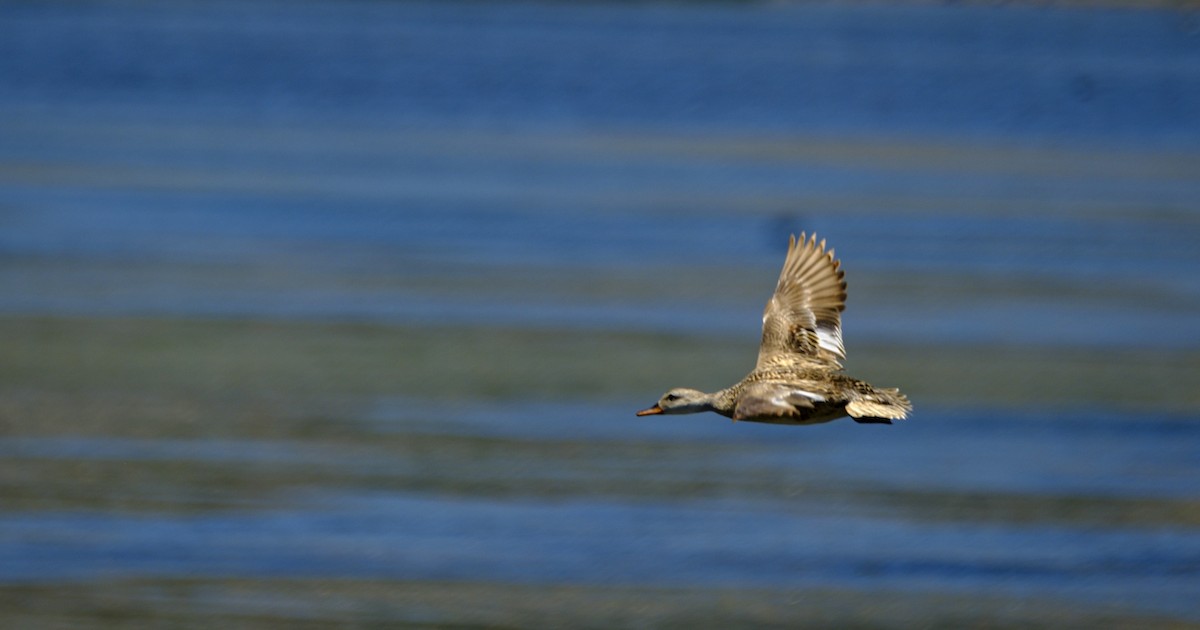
[{"x1": 0, "y1": 2, "x2": 1200, "y2": 144}]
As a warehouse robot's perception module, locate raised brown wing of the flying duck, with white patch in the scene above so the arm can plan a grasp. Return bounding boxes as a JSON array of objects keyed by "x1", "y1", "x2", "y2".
[{"x1": 756, "y1": 232, "x2": 846, "y2": 370}]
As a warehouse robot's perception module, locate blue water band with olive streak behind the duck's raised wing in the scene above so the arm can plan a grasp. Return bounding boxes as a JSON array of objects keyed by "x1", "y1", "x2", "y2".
[{"x1": 0, "y1": 202, "x2": 1200, "y2": 349}]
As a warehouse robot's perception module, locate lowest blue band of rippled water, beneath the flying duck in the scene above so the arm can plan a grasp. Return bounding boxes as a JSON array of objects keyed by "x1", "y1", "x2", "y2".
[{"x1": 0, "y1": 494, "x2": 1200, "y2": 602}]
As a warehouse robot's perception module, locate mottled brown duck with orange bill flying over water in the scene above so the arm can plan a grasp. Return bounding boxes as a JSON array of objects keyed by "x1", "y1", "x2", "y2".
[{"x1": 637, "y1": 232, "x2": 912, "y2": 425}]
